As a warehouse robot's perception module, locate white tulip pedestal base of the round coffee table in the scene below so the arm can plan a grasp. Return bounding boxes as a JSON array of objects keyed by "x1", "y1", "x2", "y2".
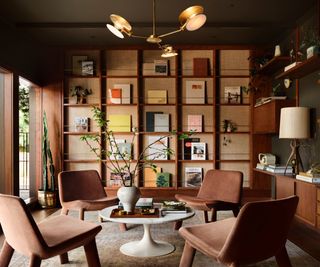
[{"x1": 120, "y1": 224, "x2": 175, "y2": 257}]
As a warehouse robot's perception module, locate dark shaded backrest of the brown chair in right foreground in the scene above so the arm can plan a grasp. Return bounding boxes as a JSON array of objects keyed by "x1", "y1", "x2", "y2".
[{"x1": 218, "y1": 196, "x2": 299, "y2": 264}]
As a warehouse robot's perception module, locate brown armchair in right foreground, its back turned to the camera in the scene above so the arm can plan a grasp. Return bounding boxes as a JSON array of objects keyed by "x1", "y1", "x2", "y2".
[{"x1": 179, "y1": 196, "x2": 299, "y2": 267}]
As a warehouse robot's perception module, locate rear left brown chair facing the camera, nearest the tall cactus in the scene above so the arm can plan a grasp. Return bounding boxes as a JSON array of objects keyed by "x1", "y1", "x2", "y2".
[{"x1": 58, "y1": 170, "x2": 118, "y2": 220}]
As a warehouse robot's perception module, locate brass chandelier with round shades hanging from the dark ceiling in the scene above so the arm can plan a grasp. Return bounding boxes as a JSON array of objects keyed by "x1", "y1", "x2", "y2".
[{"x1": 107, "y1": 0, "x2": 207, "y2": 57}]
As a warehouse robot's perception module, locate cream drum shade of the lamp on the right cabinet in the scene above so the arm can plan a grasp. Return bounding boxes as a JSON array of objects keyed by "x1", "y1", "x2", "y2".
[{"x1": 279, "y1": 107, "x2": 310, "y2": 139}]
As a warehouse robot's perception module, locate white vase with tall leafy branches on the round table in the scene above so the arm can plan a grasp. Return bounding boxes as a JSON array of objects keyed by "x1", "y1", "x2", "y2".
[{"x1": 80, "y1": 107, "x2": 192, "y2": 213}]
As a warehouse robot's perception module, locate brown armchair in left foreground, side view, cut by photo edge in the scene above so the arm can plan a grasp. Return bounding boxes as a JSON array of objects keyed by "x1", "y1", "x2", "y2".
[{"x1": 0, "y1": 195, "x2": 102, "y2": 267}]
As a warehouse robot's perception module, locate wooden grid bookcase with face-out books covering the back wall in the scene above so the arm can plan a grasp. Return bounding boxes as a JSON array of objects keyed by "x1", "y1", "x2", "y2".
[{"x1": 62, "y1": 47, "x2": 251, "y2": 195}]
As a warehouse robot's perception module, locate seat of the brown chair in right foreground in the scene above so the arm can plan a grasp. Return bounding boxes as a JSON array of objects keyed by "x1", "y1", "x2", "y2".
[{"x1": 179, "y1": 218, "x2": 237, "y2": 259}]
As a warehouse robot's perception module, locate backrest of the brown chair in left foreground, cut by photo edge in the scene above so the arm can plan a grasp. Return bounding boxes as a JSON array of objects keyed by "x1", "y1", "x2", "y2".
[{"x1": 0, "y1": 194, "x2": 47, "y2": 258}]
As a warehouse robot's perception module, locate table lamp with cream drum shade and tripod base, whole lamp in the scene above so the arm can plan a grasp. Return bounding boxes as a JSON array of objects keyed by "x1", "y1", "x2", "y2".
[{"x1": 279, "y1": 107, "x2": 310, "y2": 174}]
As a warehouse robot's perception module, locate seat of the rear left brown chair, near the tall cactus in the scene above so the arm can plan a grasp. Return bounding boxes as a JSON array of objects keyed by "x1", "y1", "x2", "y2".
[{"x1": 63, "y1": 197, "x2": 119, "y2": 210}]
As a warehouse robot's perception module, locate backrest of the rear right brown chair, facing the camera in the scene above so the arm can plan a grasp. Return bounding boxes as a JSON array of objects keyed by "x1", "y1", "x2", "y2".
[{"x1": 198, "y1": 170, "x2": 243, "y2": 203}]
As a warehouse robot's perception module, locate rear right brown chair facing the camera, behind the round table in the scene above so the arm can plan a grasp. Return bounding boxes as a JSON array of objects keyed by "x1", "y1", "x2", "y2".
[{"x1": 175, "y1": 170, "x2": 243, "y2": 224}]
